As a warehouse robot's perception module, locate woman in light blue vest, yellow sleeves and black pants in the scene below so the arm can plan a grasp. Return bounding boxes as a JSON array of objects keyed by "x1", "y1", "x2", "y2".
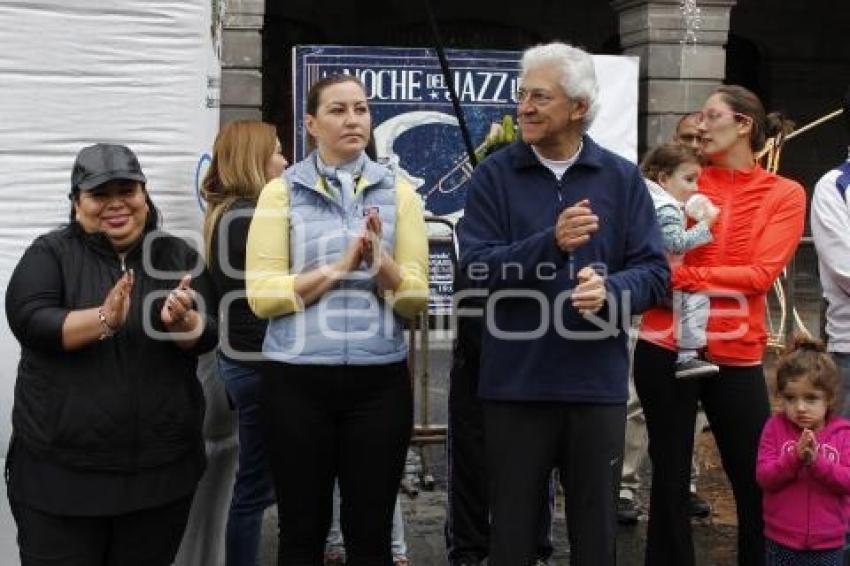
[{"x1": 246, "y1": 75, "x2": 428, "y2": 566}]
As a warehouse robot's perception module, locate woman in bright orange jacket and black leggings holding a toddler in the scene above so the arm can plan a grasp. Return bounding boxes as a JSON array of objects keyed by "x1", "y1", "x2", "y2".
[{"x1": 634, "y1": 86, "x2": 806, "y2": 566}]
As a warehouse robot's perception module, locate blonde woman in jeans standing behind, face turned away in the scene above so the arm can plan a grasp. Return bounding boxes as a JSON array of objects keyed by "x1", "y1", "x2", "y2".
[{"x1": 202, "y1": 120, "x2": 287, "y2": 566}]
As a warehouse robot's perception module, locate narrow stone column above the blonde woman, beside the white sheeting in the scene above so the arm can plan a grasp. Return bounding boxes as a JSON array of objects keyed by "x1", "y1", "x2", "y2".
[{"x1": 221, "y1": 0, "x2": 266, "y2": 124}]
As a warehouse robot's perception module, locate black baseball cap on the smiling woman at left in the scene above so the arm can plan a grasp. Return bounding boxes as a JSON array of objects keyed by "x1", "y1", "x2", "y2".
[{"x1": 71, "y1": 143, "x2": 147, "y2": 193}]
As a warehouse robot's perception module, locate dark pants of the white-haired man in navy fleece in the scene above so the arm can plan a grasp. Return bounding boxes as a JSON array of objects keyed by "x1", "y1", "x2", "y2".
[{"x1": 484, "y1": 401, "x2": 626, "y2": 566}]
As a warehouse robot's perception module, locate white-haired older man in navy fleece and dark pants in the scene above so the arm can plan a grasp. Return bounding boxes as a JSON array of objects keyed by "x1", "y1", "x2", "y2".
[{"x1": 459, "y1": 43, "x2": 669, "y2": 566}]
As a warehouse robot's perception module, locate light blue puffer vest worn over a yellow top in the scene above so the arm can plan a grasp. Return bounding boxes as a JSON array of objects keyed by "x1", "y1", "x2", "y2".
[{"x1": 263, "y1": 154, "x2": 407, "y2": 365}]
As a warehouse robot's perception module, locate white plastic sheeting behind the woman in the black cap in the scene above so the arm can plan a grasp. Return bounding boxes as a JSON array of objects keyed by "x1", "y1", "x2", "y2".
[{"x1": 0, "y1": 0, "x2": 235, "y2": 566}]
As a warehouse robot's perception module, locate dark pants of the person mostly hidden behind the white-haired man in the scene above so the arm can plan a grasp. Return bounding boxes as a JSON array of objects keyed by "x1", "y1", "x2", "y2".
[{"x1": 445, "y1": 334, "x2": 555, "y2": 563}]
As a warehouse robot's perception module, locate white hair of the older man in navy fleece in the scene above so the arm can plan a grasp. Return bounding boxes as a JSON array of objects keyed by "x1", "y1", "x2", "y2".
[{"x1": 521, "y1": 41, "x2": 599, "y2": 131}]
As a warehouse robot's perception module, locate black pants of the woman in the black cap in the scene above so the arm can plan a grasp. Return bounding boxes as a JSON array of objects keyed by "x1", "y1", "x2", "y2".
[{"x1": 9, "y1": 496, "x2": 192, "y2": 566}]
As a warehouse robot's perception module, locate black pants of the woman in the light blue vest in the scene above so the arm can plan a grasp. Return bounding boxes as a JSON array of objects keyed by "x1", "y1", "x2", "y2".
[{"x1": 260, "y1": 363, "x2": 413, "y2": 566}]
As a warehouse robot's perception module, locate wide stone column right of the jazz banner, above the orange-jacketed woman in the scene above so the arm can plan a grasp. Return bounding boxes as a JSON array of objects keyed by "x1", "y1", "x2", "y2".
[{"x1": 611, "y1": 0, "x2": 737, "y2": 154}]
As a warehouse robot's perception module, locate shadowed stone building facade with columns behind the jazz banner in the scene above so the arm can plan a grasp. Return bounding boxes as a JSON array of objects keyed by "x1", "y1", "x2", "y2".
[{"x1": 221, "y1": 0, "x2": 850, "y2": 192}]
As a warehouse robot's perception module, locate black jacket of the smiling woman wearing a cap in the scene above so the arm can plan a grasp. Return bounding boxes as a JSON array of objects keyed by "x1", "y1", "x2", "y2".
[{"x1": 6, "y1": 223, "x2": 217, "y2": 472}]
